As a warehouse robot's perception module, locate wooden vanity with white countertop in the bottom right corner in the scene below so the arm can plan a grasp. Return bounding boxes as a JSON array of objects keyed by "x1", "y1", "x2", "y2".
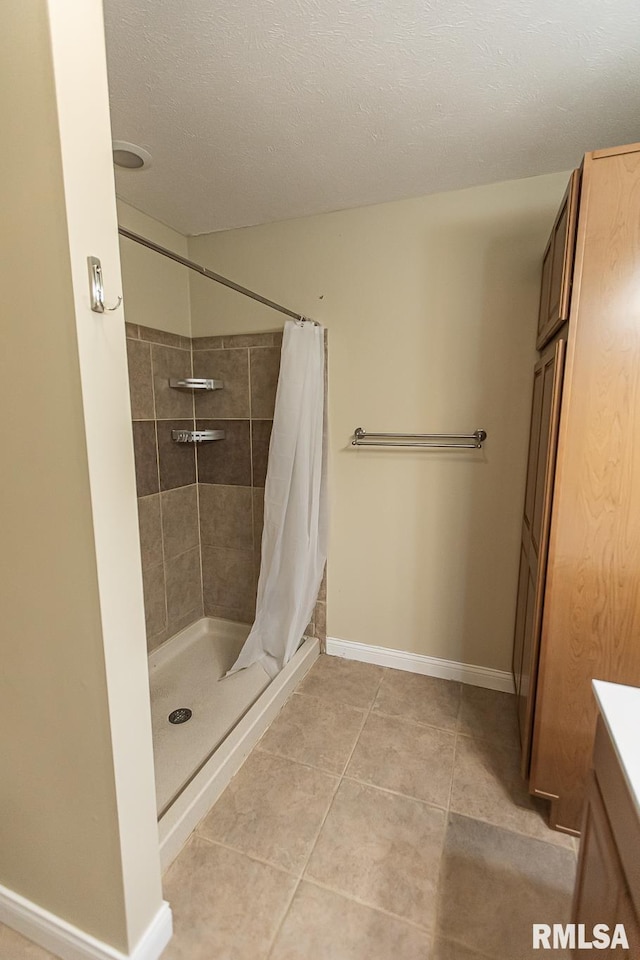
[{"x1": 572, "y1": 680, "x2": 640, "y2": 960}]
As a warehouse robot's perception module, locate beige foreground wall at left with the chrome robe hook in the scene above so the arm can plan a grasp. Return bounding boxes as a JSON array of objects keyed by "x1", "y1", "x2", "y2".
[{"x1": 0, "y1": 0, "x2": 162, "y2": 955}]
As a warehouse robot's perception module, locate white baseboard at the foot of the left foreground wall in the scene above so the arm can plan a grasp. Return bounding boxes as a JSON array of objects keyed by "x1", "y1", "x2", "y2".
[{"x1": 0, "y1": 885, "x2": 172, "y2": 960}]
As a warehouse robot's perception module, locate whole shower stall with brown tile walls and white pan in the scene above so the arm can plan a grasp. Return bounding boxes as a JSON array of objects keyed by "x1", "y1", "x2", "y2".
[{"x1": 121, "y1": 231, "x2": 326, "y2": 864}]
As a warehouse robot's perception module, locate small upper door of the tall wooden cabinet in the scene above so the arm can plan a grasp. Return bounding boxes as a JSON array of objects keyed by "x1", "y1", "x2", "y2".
[{"x1": 538, "y1": 170, "x2": 580, "y2": 350}]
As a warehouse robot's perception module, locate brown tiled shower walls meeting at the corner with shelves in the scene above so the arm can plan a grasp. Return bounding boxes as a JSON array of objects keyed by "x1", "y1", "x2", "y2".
[{"x1": 127, "y1": 324, "x2": 326, "y2": 650}]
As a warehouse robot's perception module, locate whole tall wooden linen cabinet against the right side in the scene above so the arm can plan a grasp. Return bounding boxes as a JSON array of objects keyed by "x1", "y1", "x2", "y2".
[{"x1": 513, "y1": 144, "x2": 640, "y2": 834}]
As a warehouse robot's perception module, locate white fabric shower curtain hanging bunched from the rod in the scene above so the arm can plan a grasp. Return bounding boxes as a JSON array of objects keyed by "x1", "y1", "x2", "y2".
[{"x1": 229, "y1": 320, "x2": 328, "y2": 677}]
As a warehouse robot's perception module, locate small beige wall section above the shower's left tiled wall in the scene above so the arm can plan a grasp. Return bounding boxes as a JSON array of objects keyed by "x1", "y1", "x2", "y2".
[{"x1": 118, "y1": 199, "x2": 191, "y2": 337}]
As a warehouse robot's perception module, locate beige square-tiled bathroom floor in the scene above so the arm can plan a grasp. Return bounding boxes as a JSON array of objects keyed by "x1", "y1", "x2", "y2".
[{"x1": 0, "y1": 656, "x2": 576, "y2": 960}]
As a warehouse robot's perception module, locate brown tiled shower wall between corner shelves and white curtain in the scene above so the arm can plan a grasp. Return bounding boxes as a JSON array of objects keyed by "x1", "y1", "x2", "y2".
[{"x1": 192, "y1": 333, "x2": 281, "y2": 622}]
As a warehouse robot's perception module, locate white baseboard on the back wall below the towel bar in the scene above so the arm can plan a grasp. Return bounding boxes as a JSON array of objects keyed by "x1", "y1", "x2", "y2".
[{"x1": 327, "y1": 637, "x2": 514, "y2": 693}]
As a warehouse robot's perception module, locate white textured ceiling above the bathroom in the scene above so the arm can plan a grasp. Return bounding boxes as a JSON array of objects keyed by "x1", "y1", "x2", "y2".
[{"x1": 105, "y1": 0, "x2": 640, "y2": 234}]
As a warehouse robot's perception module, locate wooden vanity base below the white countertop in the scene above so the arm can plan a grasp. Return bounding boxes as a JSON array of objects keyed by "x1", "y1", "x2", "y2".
[{"x1": 572, "y1": 721, "x2": 640, "y2": 960}]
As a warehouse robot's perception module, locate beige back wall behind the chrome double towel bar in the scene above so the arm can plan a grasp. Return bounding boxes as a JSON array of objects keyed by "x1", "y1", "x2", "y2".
[{"x1": 189, "y1": 174, "x2": 568, "y2": 670}]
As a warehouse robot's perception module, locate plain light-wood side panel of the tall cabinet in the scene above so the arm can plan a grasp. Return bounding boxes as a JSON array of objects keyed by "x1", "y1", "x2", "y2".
[{"x1": 531, "y1": 146, "x2": 640, "y2": 831}]
